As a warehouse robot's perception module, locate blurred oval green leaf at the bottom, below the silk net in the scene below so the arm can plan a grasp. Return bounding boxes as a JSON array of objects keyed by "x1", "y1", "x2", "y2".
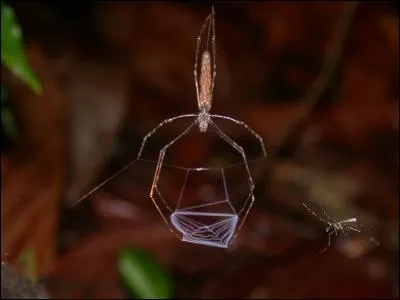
[{"x1": 118, "y1": 249, "x2": 172, "y2": 299}]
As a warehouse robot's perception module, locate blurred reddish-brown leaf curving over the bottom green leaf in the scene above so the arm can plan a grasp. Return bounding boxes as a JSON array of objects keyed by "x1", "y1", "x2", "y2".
[{"x1": 45, "y1": 223, "x2": 177, "y2": 299}]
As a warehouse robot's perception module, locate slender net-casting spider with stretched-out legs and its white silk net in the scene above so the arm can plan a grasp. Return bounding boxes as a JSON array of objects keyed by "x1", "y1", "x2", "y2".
[{"x1": 137, "y1": 8, "x2": 267, "y2": 248}]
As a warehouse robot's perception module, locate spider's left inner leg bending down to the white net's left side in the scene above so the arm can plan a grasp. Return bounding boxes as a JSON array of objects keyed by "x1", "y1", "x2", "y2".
[{"x1": 150, "y1": 115, "x2": 198, "y2": 239}]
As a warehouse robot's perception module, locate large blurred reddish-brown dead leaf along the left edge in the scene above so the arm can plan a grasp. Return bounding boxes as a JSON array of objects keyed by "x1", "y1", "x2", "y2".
[{"x1": 1, "y1": 45, "x2": 66, "y2": 274}]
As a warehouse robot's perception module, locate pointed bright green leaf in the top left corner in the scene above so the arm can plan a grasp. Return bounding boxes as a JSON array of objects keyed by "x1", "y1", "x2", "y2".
[{"x1": 1, "y1": 2, "x2": 42, "y2": 95}]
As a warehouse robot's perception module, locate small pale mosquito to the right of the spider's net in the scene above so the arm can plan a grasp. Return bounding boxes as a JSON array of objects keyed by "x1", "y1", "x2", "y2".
[{"x1": 303, "y1": 203, "x2": 361, "y2": 253}]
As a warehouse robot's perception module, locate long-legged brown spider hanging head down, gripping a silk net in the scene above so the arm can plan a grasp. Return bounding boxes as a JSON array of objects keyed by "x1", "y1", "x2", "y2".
[{"x1": 137, "y1": 7, "x2": 267, "y2": 247}]
